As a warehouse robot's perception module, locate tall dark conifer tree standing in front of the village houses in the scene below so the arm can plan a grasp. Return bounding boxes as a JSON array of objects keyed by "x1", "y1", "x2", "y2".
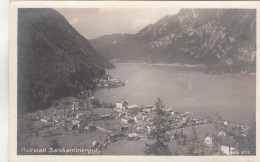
[{"x1": 145, "y1": 98, "x2": 171, "y2": 155}]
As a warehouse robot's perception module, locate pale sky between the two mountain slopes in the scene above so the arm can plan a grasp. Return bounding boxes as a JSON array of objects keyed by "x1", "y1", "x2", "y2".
[{"x1": 56, "y1": 8, "x2": 179, "y2": 39}]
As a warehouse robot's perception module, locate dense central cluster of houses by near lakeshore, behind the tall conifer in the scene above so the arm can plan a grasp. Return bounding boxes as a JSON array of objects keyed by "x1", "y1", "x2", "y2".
[{"x1": 114, "y1": 99, "x2": 212, "y2": 139}]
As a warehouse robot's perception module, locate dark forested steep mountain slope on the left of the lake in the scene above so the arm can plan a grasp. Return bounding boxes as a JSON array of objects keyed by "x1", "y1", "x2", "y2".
[{"x1": 18, "y1": 8, "x2": 114, "y2": 113}]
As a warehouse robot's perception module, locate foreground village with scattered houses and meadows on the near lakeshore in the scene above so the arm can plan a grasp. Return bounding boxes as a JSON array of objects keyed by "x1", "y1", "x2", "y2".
[{"x1": 19, "y1": 92, "x2": 250, "y2": 155}]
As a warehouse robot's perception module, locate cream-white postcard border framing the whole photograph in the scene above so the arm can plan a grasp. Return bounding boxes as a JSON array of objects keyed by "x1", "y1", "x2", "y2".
[{"x1": 9, "y1": 1, "x2": 260, "y2": 162}]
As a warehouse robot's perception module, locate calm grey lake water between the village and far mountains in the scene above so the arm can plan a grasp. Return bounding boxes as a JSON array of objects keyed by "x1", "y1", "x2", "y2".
[{"x1": 95, "y1": 63, "x2": 256, "y2": 126}]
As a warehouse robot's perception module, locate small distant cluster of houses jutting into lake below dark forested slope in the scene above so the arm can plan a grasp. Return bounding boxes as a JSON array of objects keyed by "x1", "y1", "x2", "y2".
[{"x1": 97, "y1": 75, "x2": 126, "y2": 88}]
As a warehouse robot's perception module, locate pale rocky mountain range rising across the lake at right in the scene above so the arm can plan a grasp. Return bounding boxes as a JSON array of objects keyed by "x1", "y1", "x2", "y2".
[{"x1": 90, "y1": 9, "x2": 256, "y2": 73}]
